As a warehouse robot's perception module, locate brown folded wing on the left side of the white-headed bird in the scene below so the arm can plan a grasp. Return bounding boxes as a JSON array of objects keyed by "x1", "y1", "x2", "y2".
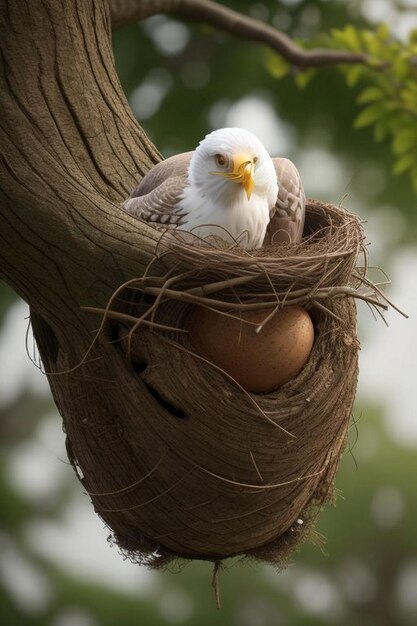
[{"x1": 123, "y1": 152, "x2": 192, "y2": 227}]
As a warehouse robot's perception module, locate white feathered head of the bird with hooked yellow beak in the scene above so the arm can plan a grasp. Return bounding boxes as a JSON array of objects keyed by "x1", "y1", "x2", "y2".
[{"x1": 188, "y1": 128, "x2": 278, "y2": 207}]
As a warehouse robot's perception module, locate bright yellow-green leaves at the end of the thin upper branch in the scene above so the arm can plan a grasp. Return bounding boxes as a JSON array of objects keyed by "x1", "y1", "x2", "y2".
[{"x1": 267, "y1": 23, "x2": 417, "y2": 191}]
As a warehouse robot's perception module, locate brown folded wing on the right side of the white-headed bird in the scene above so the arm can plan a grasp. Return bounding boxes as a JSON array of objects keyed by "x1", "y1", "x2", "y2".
[{"x1": 264, "y1": 158, "x2": 306, "y2": 244}]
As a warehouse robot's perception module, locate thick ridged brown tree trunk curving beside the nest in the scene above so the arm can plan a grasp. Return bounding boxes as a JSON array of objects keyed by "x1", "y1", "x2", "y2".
[{"x1": 0, "y1": 0, "x2": 160, "y2": 356}]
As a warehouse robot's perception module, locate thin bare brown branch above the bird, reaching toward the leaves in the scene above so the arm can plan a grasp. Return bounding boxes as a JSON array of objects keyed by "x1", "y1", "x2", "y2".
[{"x1": 108, "y1": 0, "x2": 369, "y2": 68}]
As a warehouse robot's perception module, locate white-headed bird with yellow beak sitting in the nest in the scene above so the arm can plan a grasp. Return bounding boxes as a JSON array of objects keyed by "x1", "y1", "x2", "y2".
[{"x1": 123, "y1": 128, "x2": 305, "y2": 249}]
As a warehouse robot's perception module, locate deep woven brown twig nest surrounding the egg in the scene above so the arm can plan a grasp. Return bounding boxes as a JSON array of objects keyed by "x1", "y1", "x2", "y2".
[{"x1": 79, "y1": 202, "x2": 392, "y2": 567}]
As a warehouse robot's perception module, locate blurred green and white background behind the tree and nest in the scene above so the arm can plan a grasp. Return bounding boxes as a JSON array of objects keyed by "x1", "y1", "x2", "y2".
[{"x1": 0, "y1": 0, "x2": 417, "y2": 626}]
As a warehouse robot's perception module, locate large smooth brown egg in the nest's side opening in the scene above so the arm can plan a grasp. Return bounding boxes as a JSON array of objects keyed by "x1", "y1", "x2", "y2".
[{"x1": 187, "y1": 306, "x2": 314, "y2": 393}]
